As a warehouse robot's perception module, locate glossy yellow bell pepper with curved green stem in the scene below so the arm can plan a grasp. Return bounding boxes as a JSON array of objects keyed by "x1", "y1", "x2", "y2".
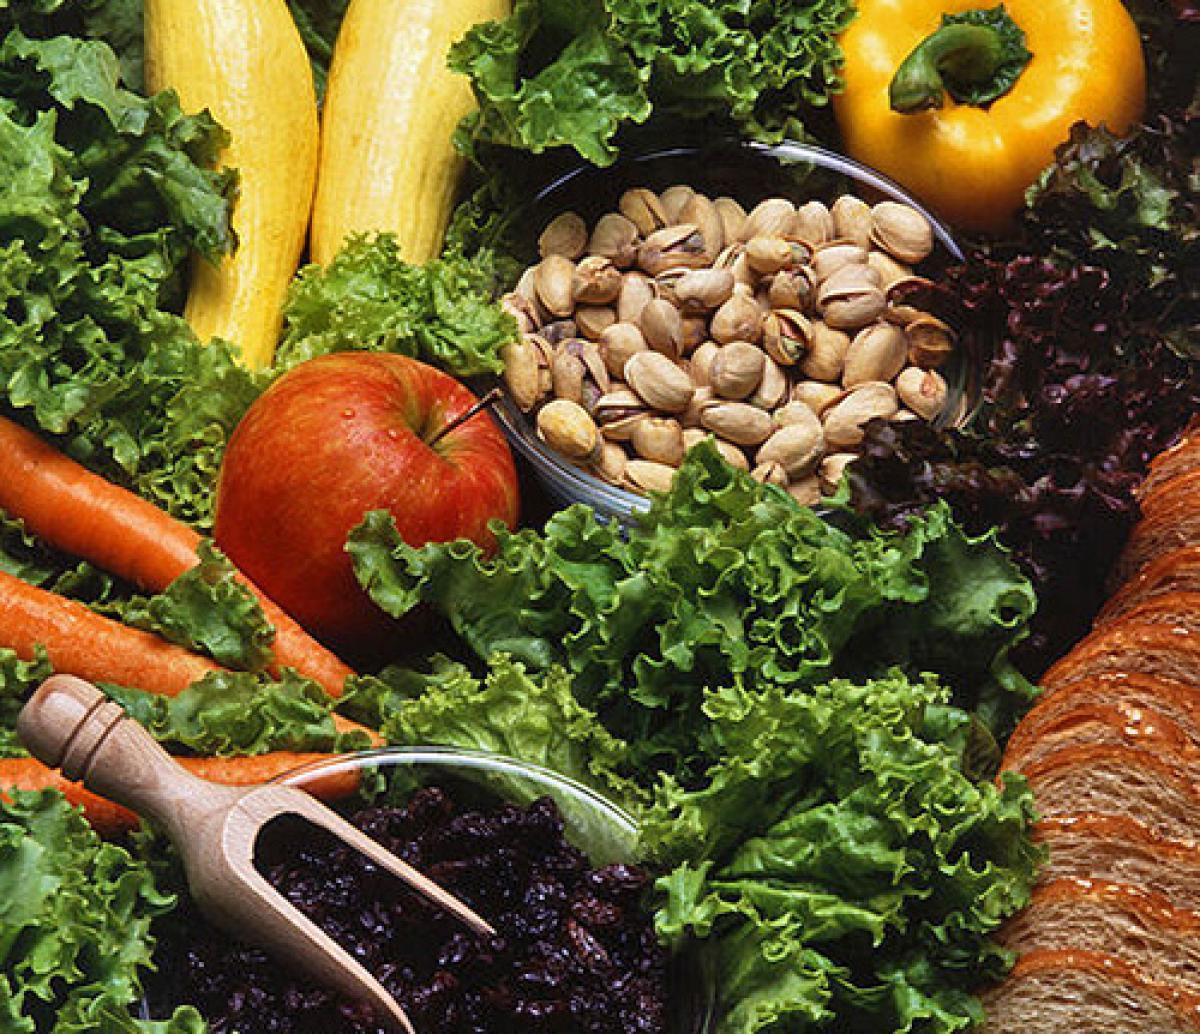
[{"x1": 834, "y1": 0, "x2": 1146, "y2": 232}]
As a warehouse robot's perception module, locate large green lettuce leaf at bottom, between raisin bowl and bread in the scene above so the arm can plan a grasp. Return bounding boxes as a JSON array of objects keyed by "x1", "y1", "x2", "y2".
[{"x1": 641, "y1": 675, "x2": 1040, "y2": 1034}]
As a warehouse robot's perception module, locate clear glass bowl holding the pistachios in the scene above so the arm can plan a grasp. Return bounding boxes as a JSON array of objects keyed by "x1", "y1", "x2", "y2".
[{"x1": 493, "y1": 140, "x2": 979, "y2": 522}]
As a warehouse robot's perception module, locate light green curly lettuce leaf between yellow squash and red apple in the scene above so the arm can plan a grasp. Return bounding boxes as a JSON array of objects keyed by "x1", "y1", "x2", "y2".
[{"x1": 276, "y1": 234, "x2": 516, "y2": 377}]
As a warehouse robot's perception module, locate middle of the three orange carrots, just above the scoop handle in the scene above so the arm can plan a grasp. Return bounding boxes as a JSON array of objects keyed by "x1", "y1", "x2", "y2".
[{"x1": 0, "y1": 571, "x2": 222, "y2": 697}]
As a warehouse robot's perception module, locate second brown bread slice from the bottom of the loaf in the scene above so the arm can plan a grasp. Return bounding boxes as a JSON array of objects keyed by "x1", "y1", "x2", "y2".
[{"x1": 1000, "y1": 879, "x2": 1200, "y2": 996}]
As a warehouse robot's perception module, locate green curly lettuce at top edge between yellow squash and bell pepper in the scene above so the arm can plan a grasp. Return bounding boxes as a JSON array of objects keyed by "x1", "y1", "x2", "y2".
[{"x1": 450, "y1": 0, "x2": 854, "y2": 166}]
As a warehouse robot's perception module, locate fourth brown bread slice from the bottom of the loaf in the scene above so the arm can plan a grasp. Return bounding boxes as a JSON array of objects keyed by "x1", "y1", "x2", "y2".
[{"x1": 1016, "y1": 744, "x2": 1200, "y2": 840}]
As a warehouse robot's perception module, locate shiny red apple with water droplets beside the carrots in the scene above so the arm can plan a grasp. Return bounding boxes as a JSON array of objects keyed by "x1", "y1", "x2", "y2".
[{"x1": 215, "y1": 351, "x2": 518, "y2": 651}]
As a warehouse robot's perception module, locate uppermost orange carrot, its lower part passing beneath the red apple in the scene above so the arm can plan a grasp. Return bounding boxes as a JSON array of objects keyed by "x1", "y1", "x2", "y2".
[{"x1": 0, "y1": 417, "x2": 354, "y2": 697}]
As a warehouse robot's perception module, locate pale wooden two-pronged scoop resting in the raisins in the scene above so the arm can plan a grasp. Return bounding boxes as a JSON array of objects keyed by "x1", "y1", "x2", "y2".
[{"x1": 17, "y1": 675, "x2": 494, "y2": 1034}]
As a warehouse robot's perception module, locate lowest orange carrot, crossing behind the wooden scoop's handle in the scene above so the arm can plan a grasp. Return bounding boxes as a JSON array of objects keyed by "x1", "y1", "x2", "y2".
[{"x1": 0, "y1": 751, "x2": 359, "y2": 836}]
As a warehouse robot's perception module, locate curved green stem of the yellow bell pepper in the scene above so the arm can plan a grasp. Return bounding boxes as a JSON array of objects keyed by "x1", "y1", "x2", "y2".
[{"x1": 888, "y1": 5, "x2": 1033, "y2": 114}]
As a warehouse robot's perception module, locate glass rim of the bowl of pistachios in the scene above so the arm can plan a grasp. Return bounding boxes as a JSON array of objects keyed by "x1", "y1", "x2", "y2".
[{"x1": 493, "y1": 136, "x2": 978, "y2": 521}]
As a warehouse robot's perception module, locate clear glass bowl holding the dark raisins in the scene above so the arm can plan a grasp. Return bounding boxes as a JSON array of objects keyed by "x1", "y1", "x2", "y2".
[{"x1": 276, "y1": 747, "x2": 715, "y2": 1034}]
